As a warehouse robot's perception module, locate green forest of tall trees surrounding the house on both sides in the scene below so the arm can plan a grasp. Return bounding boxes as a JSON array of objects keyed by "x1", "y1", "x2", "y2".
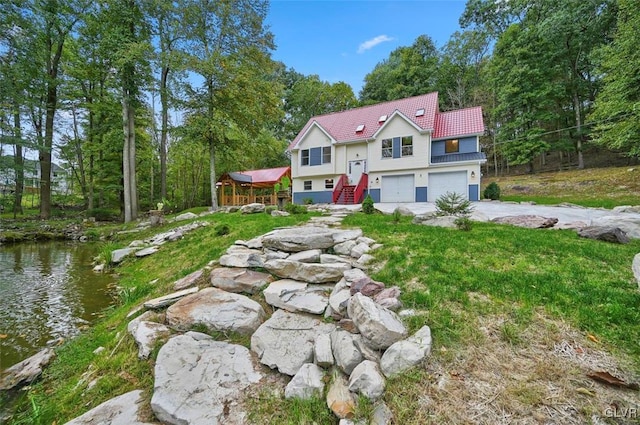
[{"x1": 0, "y1": 0, "x2": 640, "y2": 222}]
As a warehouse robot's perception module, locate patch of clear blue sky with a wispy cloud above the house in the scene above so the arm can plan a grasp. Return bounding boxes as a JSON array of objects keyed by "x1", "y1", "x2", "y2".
[{"x1": 267, "y1": 0, "x2": 466, "y2": 96}]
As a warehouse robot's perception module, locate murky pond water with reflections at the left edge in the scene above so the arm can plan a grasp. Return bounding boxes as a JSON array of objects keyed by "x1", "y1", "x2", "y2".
[{"x1": 0, "y1": 242, "x2": 114, "y2": 370}]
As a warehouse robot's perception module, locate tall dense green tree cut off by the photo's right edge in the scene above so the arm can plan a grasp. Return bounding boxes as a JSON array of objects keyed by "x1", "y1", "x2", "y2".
[{"x1": 590, "y1": 0, "x2": 640, "y2": 158}]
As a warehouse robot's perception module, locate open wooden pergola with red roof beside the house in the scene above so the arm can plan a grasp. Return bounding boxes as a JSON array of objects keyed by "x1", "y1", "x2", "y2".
[{"x1": 216, "y1": 167, "x2": 291, "y2": 206}]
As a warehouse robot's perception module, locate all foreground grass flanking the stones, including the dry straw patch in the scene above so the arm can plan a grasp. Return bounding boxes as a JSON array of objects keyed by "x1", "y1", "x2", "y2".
[{"x1": 5, "y1": 201, "x2": 640, "y2": 424}]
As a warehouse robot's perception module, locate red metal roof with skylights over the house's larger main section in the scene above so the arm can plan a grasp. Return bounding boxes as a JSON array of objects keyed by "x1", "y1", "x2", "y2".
[{"x1": 289, "y1": 92, "x2": 438, "y2": 149}]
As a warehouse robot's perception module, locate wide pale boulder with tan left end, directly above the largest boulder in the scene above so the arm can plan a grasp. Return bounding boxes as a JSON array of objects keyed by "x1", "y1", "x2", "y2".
[{"x1": 167, "y1": 288, "x2": 266, "y2": 335}]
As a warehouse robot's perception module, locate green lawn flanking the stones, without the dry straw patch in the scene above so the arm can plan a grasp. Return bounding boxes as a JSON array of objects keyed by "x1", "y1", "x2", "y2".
[{"x1": 5, "y1": 213, "x2": 640, "y2": 424}]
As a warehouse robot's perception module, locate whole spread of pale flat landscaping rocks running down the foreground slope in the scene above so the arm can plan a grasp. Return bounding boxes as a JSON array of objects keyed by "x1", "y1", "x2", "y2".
[{"x1": 58, "y1": 213, "x2": 431, "y2": 424}]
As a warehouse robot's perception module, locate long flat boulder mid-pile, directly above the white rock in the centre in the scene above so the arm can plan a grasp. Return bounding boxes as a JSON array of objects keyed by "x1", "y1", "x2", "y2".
[{"x1": 264, "y1": 258, "x2": 351, "y2": 283}]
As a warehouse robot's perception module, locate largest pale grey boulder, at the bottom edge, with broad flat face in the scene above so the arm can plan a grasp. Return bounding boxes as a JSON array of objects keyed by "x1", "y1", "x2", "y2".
[{"x1": 151, "y1": 332, "x2": 262, "y2": 425}]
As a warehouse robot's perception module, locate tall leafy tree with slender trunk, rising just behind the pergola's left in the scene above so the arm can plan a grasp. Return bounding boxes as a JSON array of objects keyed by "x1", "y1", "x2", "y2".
[{"x1": 182, "y1": 0, "x2": 280, "y2": 210}]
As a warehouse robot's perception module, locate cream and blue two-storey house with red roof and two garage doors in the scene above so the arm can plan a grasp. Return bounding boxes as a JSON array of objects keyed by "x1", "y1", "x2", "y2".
[{"x1": 289, "y1": 93, "x2": 486, "y2": 204}]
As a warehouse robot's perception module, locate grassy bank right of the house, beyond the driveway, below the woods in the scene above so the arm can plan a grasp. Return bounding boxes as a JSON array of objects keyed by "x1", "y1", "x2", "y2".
[{"x1": 482, "y1": 167, "x2": 640, "y2": 208}]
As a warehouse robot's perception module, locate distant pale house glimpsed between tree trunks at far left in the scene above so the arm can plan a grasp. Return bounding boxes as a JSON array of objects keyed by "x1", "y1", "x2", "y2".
[{"x1": 0, "y1": 155, "x2": 72, "y2": 195}]
